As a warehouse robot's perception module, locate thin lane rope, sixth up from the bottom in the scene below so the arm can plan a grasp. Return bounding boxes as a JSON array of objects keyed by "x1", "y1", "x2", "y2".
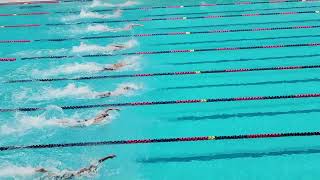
[{"x1": 44, "y1": 10, "x2": 320, "y2": 26}]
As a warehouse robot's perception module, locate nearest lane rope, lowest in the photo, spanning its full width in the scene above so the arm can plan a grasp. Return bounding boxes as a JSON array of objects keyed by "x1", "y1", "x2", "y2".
[{"x1": 0, "y1": 131, "x2": 320, "y2": 151}]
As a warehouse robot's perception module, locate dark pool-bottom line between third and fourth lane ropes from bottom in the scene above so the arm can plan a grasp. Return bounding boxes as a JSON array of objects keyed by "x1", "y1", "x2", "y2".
[{"x1": 166, "y1": 54, "x2": 320, "y2": 66}]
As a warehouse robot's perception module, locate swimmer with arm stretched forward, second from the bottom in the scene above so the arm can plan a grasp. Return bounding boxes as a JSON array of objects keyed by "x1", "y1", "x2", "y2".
[{"x1": 58, "y1": 108, "x2": 120, "y2": 127}]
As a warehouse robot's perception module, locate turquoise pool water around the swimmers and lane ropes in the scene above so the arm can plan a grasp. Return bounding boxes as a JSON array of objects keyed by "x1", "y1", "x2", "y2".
[{"x1": 0, "y1": 0, "x2": 320, "y2": 180}]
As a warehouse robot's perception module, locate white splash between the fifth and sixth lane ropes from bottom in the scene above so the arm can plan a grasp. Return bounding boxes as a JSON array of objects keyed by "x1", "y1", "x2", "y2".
[{"x1": 85, "y1": 24, "x2": 143, "y2": 32}]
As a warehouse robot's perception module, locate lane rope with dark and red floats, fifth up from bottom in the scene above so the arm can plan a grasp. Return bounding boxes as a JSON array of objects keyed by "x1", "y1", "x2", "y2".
[{"x1": 15, "y1": 25, "x2": 320, "y2": 43}]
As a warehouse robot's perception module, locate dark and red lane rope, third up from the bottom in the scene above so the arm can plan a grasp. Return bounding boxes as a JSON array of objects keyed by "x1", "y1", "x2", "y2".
[{"x1": 5, "y1": 65, "x2": 320, "y2": 83}]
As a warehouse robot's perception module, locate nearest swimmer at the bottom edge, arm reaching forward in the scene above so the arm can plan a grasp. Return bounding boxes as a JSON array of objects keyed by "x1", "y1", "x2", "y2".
[{"x1": 35, "y1": 155, "x2": 116, "y2": 179}]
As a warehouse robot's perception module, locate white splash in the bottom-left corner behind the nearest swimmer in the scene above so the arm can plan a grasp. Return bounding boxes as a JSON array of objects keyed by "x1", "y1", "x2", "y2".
[{"x1": 0, "y1": 165, "x2": 36, "y2": 177}]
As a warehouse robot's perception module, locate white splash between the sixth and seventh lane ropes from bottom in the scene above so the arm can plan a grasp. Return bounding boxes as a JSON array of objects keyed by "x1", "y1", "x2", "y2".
[{"x1": 62, "y1": 9, "x2": 122, "y2": 21}]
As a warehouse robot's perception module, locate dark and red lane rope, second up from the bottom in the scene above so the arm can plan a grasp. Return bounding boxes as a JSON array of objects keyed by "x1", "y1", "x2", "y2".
[{"x1": 0, "y1": 93, "x2": 320, "y2": 112}]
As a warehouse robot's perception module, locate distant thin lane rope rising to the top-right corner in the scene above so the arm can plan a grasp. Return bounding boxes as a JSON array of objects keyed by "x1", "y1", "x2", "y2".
[{"x1": 56, "y1": 0, "x2": 319, "y2": 14}]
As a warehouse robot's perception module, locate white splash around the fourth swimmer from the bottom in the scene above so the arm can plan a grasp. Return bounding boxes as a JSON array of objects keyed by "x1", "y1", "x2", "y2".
[{"x1": 31, "y1": 56, "x2": 141, "y2": 76}]
